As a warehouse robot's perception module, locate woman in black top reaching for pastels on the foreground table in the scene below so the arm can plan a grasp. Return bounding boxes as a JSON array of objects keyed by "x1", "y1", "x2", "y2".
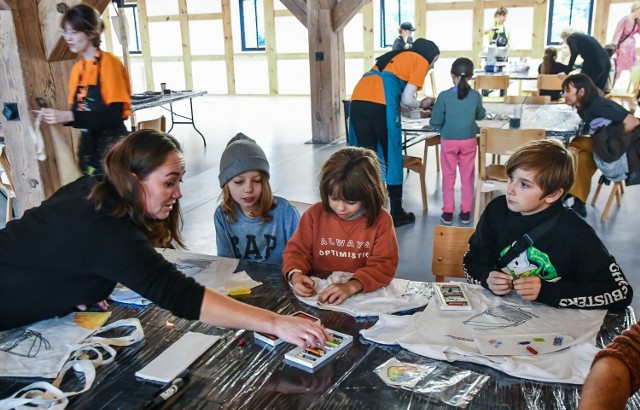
[{"x1": 0, "y1": 130, "x2": 328, "y2": 346}]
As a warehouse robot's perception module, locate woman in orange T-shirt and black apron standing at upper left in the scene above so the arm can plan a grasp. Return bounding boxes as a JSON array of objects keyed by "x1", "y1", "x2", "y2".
[{"x1": 42, "y1": 4, "x2": 131, "y2": 175}]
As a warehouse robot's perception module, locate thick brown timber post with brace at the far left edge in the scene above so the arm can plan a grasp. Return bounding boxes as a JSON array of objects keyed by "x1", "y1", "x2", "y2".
[{"x1": 0, "y1": 0, "x2": 109, "y2": 217}]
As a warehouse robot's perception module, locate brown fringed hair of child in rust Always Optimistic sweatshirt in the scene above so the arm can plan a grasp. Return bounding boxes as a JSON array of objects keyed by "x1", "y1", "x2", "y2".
[{"x1": 320, "y1": 147, "x2": 386, "y2": 227}]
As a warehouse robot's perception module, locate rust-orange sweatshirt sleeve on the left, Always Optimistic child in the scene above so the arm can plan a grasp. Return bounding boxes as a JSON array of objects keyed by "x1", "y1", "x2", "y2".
[{"x1": 282, "y1": 202, "x2": 323, "y2": 280}]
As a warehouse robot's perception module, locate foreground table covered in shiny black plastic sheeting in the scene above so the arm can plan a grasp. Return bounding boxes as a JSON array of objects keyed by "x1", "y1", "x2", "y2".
[{"x1": 0, "y1": 256, "x2": 640, "y2": 409}]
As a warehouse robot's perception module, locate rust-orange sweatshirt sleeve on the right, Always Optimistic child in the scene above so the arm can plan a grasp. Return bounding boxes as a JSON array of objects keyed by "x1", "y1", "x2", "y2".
[{"x1": 353, "y1": 209, "x2": 400, "y2": 292}]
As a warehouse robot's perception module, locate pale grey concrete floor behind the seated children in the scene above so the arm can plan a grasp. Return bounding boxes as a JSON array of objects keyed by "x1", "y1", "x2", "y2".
[{"x1": 2, "y1": 96, "x2": 640, "y2": 318}]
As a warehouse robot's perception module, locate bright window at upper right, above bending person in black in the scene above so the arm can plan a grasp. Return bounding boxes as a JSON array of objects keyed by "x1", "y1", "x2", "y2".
[{"x1": 547, "y1": 0, "x2": 593, "y2": 45}]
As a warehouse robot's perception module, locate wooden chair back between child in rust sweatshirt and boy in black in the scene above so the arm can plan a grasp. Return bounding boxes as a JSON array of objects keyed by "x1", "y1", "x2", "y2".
[{"x1": 431, "y1": 225, "x2": 476, "y2": 282}]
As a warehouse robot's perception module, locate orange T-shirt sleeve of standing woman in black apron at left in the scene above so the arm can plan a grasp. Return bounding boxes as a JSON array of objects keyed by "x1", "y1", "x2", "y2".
[{"x1": 100, "y1": 52, "x2": 131, "y2": 120}]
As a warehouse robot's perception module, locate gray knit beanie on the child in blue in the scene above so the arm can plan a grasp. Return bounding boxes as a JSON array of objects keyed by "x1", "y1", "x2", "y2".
[{"x1": 218, "y1": 132, "x2": 269, "y2": 188}]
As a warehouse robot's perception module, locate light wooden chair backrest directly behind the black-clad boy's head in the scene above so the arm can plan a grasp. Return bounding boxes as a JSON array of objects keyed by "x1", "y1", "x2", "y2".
[{"x1": 478, "y1": 128, "x2": 545, "y2": 180}]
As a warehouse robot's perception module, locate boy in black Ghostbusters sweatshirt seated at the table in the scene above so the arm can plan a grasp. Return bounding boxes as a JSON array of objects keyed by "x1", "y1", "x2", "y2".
[{"x1": 464, "y1": 140, "x2": 633, "y2": 309}]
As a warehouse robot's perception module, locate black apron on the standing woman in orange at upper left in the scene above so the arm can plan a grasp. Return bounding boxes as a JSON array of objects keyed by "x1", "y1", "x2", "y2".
[{"x1": 72, "y1": 54, "x2": 128, "y2": 175}]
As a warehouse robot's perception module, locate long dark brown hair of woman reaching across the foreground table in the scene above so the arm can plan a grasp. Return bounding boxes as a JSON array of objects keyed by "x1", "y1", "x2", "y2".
[{"x1": 88, "y1": 129, "x2": 184, "y2": 247}]
